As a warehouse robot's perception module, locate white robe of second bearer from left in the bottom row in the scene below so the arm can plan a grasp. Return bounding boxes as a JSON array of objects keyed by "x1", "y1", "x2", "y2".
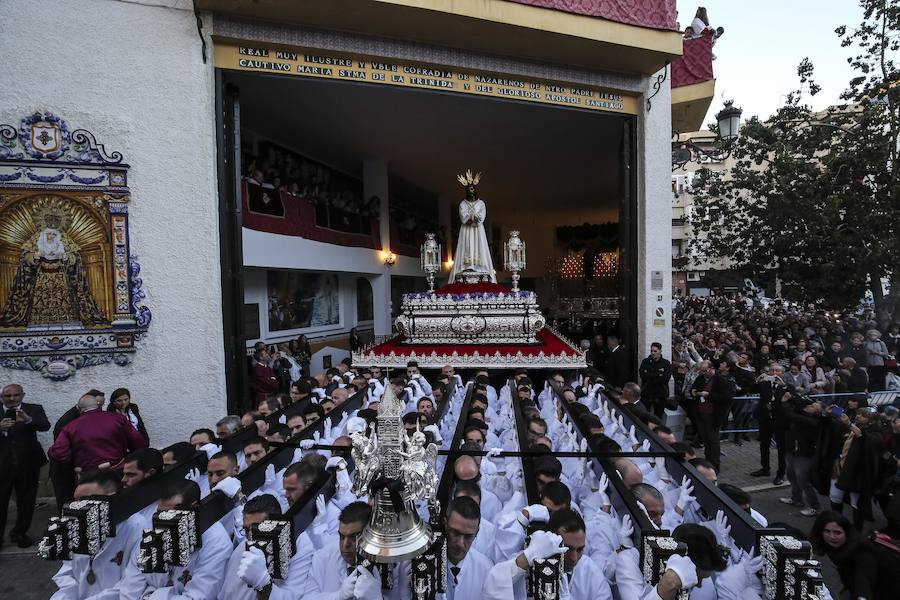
[{"x1": 98, "y1": 523, "x2": 234, "y2": 600}]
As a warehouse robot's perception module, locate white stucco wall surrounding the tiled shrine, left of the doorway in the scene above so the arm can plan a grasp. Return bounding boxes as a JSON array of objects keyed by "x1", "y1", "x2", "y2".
[{"x1": 0, "y1": 0, "x2": 225, "y2": 446}]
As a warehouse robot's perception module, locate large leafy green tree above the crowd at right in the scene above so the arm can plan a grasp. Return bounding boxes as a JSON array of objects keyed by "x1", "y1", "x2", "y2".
[{"x1": 690, "y1": 0, "x2": 900, "y2": 326}]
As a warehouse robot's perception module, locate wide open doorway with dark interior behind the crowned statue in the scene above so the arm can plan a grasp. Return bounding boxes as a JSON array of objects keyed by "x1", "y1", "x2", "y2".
[{"x1": 218, "y1": 61, "x2": 637, "y2": 410}]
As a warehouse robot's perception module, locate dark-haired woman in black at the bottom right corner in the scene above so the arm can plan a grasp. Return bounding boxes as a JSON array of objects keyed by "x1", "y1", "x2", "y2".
[{"x1": 809, "y1": 512, "x2": 897, "y2": 600}]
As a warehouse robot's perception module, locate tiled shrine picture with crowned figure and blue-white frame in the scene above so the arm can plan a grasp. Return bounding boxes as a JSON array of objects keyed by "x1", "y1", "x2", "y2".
[{"x1": 0, "y1": 112, "x2": 151, "y2": 380}]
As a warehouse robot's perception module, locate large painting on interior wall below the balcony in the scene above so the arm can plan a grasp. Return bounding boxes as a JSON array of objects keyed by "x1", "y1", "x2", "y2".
[{"x1": 267, "y1": 270, "x2": 341, "y2": 331}]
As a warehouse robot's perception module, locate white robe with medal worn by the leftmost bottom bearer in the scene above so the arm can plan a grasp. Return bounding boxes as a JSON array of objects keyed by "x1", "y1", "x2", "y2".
[{"x1": 51, "y1": 513, "x2": 147, "y2": 600}]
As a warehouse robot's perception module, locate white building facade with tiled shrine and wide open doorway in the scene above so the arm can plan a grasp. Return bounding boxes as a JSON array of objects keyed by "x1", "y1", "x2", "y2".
[{"x1": 0, "y1": 0, "x2": 708, "y2": 443}]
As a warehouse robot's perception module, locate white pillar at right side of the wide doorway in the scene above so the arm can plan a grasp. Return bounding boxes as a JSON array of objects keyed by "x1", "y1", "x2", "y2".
[{"x1": 635, "y1": 69, "x2": 672, "y2": 360}]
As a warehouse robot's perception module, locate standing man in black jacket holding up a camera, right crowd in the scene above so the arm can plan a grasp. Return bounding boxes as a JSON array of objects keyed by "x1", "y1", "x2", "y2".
[{"x1": 779, "y1": 398, "x2": 822, "y2": 517}]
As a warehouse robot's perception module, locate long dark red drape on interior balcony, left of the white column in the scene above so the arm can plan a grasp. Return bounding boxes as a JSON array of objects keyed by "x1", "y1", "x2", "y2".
[{"x1": 241, "y1": 179, "x2": 381, "y2": 250}]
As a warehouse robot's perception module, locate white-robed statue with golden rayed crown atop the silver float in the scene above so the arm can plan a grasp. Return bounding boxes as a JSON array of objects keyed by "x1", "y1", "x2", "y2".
[{"x1": 450, "y1": 171, "x2": 497, "y2": 283}]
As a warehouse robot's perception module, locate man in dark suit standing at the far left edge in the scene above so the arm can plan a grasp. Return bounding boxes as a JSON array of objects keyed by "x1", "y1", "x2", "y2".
[{"x1": 0, "y1": 383, "x2": 50, "y2": 548}]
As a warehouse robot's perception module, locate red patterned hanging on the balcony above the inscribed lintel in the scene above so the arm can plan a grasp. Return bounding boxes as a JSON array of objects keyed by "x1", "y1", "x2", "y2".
[{"x1": 512, "y1": 0, "x2": 675, "y2": 29}]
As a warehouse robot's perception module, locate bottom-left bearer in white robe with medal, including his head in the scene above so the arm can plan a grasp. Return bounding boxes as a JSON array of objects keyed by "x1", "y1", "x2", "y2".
[{"x1": 51, "y1": 469, "x2": 146, "y2": 600}]
